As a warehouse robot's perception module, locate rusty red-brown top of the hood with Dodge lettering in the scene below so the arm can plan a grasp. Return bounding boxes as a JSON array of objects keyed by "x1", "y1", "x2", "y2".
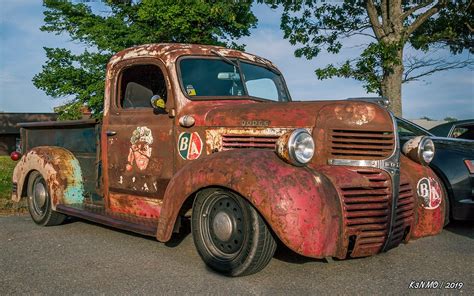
[{"x1": 180, "y1": 100, "x2": 392, "y2": 130}]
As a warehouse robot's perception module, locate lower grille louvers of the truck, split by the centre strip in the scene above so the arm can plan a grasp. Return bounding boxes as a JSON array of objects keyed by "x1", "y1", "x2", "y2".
[{"x1": 342, "y1": 169, "x2": 415, "y2": 257}]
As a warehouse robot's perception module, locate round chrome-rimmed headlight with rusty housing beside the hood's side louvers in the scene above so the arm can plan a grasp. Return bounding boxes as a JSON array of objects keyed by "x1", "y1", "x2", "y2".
[{"x1": 277, "y1": 128, "x2": 314, "y2": 165}]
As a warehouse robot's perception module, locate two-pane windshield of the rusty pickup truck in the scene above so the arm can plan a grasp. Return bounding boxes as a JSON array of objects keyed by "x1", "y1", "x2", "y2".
[{"x1": 180, "y1": 58, "x2": 289, "y2": 102}]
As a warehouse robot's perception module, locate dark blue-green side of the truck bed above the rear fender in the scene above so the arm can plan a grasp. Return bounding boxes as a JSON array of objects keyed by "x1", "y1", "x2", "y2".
[{"x1": 18, "y1": 120, "x2": 102, "y2": 202}]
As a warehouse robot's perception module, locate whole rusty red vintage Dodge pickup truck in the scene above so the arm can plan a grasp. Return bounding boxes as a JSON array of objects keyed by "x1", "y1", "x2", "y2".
[{"x1": 12, "y1": 44, "x2": 445, "y2": 276}]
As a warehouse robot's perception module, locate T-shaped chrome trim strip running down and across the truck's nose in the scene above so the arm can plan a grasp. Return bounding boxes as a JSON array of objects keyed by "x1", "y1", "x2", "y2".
[{"x1": 328, "y1": 111, "x2": 400, "y2": 251}]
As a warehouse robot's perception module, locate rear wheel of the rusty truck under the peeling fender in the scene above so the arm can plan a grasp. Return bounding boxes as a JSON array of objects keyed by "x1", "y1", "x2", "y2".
[{"x1": 27, "y1": 171, "x2": 66, "y2": 226}]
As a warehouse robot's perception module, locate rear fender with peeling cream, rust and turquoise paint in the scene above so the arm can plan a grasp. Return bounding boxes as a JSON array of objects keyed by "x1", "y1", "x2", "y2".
[{"x1": 12, "y1": 146, "x2": 84, "y2": 210}]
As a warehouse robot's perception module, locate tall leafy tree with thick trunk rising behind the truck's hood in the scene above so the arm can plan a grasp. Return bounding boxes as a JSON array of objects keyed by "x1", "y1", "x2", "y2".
[{"x1": 260, "y1": 0, "x2": 474, "y2": 115}]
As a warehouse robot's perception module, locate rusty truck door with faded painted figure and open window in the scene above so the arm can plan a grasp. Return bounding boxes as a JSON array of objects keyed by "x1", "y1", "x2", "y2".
[{"x1": 102, "y1": 59, "x2": 174, "y2": 218}]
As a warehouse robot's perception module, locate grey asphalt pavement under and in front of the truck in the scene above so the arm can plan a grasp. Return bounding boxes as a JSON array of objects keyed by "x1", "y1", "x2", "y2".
[{"x1": 0, "y1": 216, "x2": 474, "y2": 295}]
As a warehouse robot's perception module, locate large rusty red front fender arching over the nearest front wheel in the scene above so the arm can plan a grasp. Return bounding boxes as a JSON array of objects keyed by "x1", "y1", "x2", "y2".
[{"x1": 157, "y1": 149, "x2": 343, "y2": 258}]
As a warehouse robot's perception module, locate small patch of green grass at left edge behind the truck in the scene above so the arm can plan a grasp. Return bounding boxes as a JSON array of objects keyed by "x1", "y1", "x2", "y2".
[{"x1": 0, "y1": 156, "x2": 26, "y2": 214}]
